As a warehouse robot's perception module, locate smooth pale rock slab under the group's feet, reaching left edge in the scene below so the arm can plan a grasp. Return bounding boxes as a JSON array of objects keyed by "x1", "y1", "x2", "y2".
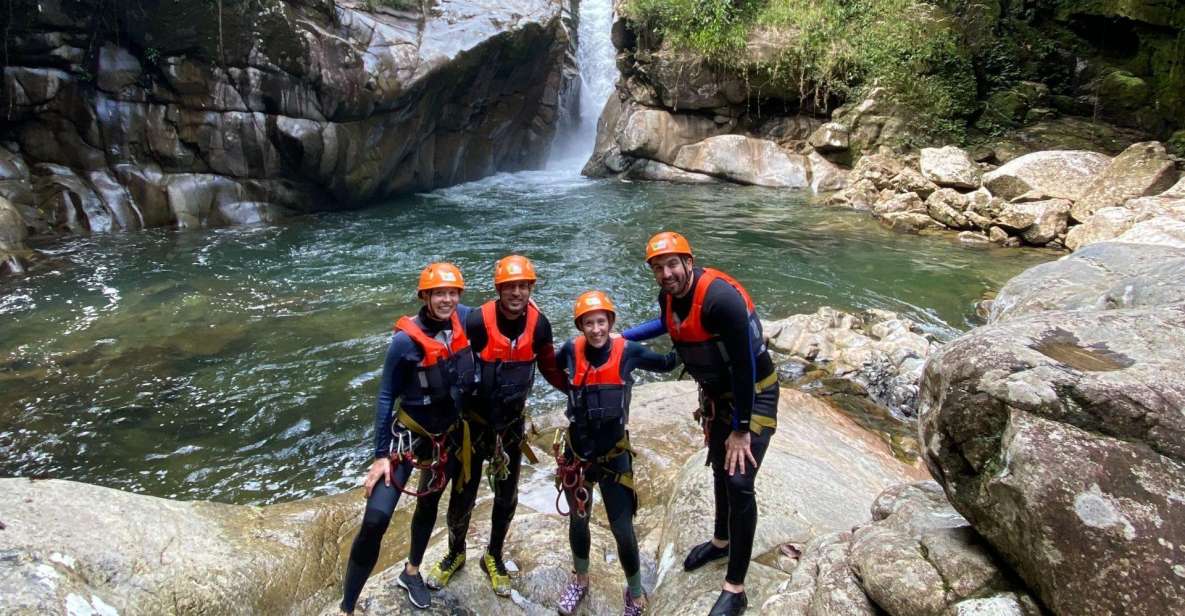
[{"x1": 0, "y1": 381, "x2": 925, "y2": 614}]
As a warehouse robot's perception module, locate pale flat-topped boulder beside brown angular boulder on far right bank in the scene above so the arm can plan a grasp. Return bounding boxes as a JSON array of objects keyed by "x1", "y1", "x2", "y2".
[{"x1": 984, "y1": 150, "x2": 1110, "y2": 201}]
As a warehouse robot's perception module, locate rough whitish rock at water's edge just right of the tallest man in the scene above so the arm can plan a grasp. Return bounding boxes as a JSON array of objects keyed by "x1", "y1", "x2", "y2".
[{"x1": 763, "y1": 307, "x2": 939, "y2": 417}]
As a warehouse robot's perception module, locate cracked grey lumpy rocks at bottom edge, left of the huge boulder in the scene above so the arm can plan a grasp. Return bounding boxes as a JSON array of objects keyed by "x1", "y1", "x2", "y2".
[{"x1": 762, "y1": 481, "x2": 1042, "y2": 616}]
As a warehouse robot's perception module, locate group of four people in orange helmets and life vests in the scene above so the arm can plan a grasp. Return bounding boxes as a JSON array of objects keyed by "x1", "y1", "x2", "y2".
[{"x1": 340, "y1": 232, "x2": 779, "y2": 616}]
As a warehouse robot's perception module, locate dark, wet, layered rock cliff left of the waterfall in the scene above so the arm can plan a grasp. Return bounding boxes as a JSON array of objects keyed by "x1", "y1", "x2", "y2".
[{"x1": 0, "y1": 0, "x2": 575, "y2": 240}]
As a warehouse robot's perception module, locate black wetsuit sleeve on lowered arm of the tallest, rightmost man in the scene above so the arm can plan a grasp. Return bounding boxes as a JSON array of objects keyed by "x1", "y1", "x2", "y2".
[{"x1": 703, "y1": 280, "x2": 757, "y2": 430}]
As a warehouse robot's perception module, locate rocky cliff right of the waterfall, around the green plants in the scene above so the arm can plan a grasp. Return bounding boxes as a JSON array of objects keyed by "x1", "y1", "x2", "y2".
[{"x1": 585, "y1": 0, "x2": 1185, "y2": 187}]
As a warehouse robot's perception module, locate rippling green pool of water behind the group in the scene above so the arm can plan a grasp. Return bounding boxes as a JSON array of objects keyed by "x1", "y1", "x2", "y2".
[{"x1": 0, "y1": 165, "x2": 1055, "y2": 503}]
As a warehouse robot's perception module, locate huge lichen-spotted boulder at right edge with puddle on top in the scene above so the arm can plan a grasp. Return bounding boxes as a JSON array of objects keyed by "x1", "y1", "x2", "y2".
[{"x1": 920, "y1": 305, "x2": 1185, "y2": 614}]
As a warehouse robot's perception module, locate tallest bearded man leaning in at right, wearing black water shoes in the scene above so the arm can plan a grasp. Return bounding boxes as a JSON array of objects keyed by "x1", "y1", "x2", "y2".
[{"x1": 624, "y1": 232, "x2": 779, "y2": 616}]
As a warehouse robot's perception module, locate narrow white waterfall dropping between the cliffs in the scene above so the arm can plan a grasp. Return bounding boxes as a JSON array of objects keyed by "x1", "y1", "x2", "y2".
[{"x1": 549, "y1": 0, "x2": 617, "y2": 169}]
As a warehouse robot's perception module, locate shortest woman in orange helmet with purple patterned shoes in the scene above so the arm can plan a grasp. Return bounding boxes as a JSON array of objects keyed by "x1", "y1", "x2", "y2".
[{"x1": 553, "y1": 291, "x2": 679, "y2": 616}]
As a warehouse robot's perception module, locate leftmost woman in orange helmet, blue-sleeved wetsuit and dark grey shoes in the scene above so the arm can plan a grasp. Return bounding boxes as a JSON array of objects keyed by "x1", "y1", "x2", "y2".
[{"x1": 340, "y1": 263, "x2": 474, "y2": 614}]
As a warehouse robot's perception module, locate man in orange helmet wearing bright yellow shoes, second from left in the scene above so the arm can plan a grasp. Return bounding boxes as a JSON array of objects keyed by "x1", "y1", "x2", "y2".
[{"x1": 428, "y1": 255, "x2": 566, "y2": 596}]
